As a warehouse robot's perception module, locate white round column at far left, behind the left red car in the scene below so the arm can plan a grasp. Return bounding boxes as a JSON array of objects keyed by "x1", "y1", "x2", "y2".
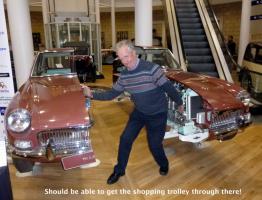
[{"x1": 6, "y1": 0, "x2": 34, "y2": 88}]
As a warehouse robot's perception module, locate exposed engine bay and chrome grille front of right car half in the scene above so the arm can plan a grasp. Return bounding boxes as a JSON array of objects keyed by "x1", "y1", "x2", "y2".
[{"x1": 165, "y1": 83, "x2": 250, "y2": 143}]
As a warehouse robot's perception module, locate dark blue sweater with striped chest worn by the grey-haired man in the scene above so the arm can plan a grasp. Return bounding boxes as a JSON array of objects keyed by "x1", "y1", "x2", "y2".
[{"x1": 93, "y1": 60, "x2": 182, "y2": 115}]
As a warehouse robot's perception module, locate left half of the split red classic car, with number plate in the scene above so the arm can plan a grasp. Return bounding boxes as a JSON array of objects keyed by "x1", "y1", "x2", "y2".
[{"x1": 5, "y1": 48, "x2": 96, "y2": 172}]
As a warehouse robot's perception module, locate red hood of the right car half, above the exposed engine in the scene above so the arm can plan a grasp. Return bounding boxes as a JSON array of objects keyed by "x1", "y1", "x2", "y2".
[{"x1": 167, "y1": 71, "x2": 244, "y2": 110}]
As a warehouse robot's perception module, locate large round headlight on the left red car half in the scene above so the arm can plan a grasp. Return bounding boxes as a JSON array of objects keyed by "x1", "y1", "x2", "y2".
[{"x1": 6, "y1": 109, "x2": 31, "y2": 132}]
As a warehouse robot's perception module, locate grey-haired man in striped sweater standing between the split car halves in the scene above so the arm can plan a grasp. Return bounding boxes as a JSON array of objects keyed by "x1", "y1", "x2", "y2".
[{"x1": 84, "y1": 40, "x2": 183, "y2": 184}]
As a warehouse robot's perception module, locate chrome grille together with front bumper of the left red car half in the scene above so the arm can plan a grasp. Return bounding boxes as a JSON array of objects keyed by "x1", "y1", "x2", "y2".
[{"x1": 10, "y1": 127, "x2": 92, "y2": 161}]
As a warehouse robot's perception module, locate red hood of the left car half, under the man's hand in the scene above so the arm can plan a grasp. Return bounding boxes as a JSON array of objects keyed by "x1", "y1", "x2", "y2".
[{"x1": 9, "y1": 76, "x2": 89, "y2": 130}]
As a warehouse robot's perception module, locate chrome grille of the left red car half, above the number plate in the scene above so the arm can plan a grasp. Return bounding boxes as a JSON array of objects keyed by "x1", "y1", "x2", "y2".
[{"x1": 38, "y1": 128, "x2": 92, "y2": 155}]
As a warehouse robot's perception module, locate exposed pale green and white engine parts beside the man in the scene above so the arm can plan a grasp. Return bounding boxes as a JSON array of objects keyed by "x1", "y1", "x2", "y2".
[{"x1": 165, "y1": 83, "x2": 209, "y2": 143}]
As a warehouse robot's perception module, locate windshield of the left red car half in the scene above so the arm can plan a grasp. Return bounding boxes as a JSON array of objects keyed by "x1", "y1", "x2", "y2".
[{"x1": 32, "y1": 51, "x2": 75, "y2": 76}]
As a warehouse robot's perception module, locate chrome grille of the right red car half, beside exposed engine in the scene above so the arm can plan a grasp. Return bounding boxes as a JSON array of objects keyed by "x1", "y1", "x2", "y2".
[{"x1": 209, "y1": 110, "x2": 243, "y2": 134}]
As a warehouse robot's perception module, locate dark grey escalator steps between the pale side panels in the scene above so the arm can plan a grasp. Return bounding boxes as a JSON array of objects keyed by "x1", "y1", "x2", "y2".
[{"x1": 175, "y1": 0, "x2": 219, "y2": 77}]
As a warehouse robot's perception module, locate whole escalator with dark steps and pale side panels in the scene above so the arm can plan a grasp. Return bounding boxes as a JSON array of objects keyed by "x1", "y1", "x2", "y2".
[{"x1": 163, "y1": 0, "x2": 236, "y2": 82}]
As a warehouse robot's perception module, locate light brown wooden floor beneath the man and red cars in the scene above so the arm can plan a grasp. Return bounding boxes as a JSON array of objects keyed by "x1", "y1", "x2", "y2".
[{"x1": 9, "y1": 67, "x2": 262, "y2": 200}]
